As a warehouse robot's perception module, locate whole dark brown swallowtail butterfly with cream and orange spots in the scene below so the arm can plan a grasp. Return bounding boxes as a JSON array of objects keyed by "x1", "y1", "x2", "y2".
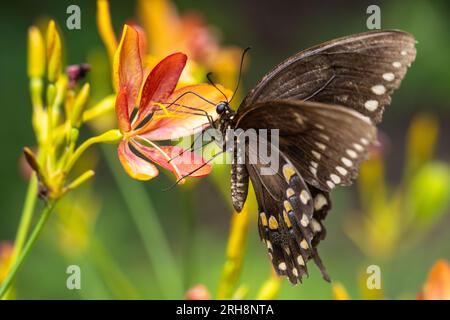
[{"x1": 209, "y1": 30, "x2": 416, "y2": 284}]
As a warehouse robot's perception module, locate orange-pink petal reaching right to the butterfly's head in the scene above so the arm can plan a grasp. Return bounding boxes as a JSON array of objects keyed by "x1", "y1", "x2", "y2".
[{"x1": 138, "y1": 84, "x2": 231, "y2": 141}]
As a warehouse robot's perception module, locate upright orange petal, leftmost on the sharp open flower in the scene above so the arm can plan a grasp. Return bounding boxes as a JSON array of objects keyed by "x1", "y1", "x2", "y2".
[{"x1": 114, "y1": 25, "x2": 143, "y2": 114}]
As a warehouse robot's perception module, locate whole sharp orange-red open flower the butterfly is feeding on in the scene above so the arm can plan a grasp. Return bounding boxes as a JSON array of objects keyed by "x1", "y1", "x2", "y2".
[{"x1": 114, "y1": 25, "x2": 230, "y2": 180}]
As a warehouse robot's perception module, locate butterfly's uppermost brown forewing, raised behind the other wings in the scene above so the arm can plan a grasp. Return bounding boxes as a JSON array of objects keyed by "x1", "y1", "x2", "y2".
[{"x1": 238, "y1": 30, "x2": 416, "y2": 123}]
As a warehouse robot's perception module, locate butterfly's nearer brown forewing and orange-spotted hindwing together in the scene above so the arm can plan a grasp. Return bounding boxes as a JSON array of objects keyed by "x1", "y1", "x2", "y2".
[{"x1": 236, "y1": 101, "x2": 376, "y2": 284}]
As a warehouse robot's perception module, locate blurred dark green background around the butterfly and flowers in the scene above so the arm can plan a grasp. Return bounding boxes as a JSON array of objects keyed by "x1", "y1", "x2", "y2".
[{"x1": 0, "y1": 0, "x2": 450, "y2": 299}]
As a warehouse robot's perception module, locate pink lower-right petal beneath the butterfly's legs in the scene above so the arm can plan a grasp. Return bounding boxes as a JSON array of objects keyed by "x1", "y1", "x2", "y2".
[{"x1": 133, "y1": 142, "x2": 212, "y2": 179}]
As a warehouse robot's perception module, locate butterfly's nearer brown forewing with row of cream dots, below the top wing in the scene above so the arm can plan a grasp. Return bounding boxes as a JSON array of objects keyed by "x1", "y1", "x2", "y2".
[{"x1": 236, "y1": 100, "x2": 376, "y2": 192}]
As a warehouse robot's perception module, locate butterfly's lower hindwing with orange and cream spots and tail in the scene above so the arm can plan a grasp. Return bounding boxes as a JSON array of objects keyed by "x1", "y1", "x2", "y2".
[{"x1": 247, "y1": 141, "x2": 329, "y2": 284}]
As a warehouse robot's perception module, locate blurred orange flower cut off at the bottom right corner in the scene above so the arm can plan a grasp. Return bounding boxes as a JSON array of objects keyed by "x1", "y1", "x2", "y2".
[{"x1": 417, "y1": 260, "x2": 450, "y2": 300}]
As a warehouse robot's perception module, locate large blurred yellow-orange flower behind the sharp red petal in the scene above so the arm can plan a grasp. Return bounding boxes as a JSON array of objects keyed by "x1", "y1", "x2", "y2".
[{"x1": 138, "y1": 0, "x2": 242, "y2": 86}]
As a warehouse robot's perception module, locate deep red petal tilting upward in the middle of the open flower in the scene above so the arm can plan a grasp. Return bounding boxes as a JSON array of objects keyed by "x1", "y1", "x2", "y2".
[{"x1": 136, "y1": 52, "x2": 187, "y2": 123}]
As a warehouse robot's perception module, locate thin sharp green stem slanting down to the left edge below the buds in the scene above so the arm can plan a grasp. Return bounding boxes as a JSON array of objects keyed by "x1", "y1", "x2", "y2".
[{"x1": 0, "y1": 201, "x2": 55, "y2": 299}]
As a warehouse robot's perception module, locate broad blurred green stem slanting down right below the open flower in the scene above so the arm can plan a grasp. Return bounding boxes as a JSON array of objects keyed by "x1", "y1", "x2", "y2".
[{"x1": 102, "y1": 145, "x2": 183, "y2": 299}]
